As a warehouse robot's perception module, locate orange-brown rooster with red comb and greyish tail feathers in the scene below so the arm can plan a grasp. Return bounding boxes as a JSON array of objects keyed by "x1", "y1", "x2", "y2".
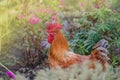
[{"x1": 47, "y1": 18, "x2": 109, "y2": 70}]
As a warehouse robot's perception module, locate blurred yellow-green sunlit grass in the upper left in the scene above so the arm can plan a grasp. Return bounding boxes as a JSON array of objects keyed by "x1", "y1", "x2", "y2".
[{"x1": 0, "y1": 0, "x2": 59, "y2": 54}]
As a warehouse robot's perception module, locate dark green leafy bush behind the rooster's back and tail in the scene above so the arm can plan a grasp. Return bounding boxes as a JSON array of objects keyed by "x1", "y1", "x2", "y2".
[{"x1": 64, "y1": 7, "x2": 120, "y2": 54}]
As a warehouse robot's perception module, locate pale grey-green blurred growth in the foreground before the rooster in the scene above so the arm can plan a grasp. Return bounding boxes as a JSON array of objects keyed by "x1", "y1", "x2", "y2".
[{"x1": 0, "y1": 63, "x2": 120, "y2": 80}]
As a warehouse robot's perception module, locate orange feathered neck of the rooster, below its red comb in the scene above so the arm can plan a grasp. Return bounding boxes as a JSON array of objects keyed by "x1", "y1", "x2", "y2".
[{"x1": 50, "y1": 31, "x2": 69, "y2": 61}]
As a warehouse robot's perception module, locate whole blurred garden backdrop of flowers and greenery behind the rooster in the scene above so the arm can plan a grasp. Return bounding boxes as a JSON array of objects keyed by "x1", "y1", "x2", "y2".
[{"x1": 0, "y1": 0, "x2": 120, "y2": 79}]
